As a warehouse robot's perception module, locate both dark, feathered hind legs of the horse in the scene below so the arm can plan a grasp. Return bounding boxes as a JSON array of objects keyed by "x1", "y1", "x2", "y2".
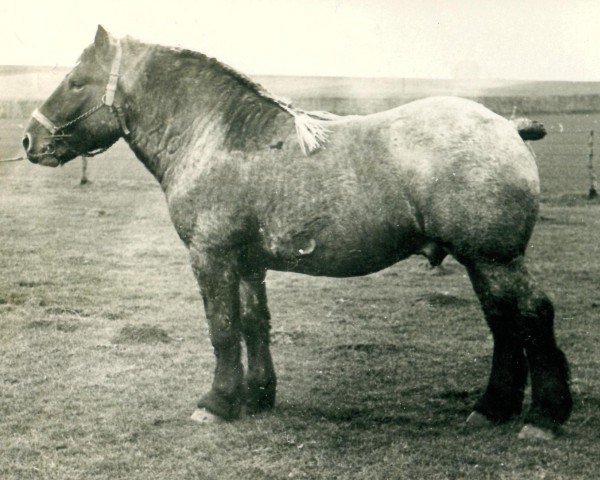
[{"x1": 467, "y1": 257, "x2": 573, "y2": 431}]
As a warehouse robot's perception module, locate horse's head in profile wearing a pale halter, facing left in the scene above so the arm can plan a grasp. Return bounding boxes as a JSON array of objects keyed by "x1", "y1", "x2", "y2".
[{"x1": 23, "y1": 26, "x2": 128, "y2": 167}]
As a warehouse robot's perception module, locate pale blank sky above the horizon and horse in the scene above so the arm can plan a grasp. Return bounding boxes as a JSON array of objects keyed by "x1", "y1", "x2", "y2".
[{"x1": 0, "y1": 0, "x2": 600, "y2": 81}]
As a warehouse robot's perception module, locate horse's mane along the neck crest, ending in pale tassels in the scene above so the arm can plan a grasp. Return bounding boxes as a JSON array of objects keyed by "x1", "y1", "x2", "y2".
[{"x1": 157, "y1": 46, "x2": 343, "y2": 155}]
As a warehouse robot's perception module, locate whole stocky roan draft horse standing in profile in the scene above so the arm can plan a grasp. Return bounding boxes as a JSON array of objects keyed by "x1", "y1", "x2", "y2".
[{"x1": 23, "y1": 27, "x2": 572, "y2": 436}]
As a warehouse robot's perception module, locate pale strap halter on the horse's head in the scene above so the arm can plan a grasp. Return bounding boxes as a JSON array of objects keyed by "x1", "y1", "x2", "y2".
[{"x1": 31, "y1": 40, "x2": 130, "y2": 150}]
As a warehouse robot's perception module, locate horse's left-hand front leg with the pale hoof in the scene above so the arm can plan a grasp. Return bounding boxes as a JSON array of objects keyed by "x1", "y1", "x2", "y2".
[{"x1": 192, "y1": 252, "x2": 244, "y2": 420}]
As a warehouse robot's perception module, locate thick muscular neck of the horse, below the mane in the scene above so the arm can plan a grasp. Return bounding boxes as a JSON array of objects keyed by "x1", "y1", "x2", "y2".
[{"x1": 123, "y1": 47, "x2": 289, "y2": 189}]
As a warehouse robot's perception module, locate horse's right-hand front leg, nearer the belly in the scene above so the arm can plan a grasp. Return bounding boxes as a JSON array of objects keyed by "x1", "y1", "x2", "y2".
[{"x1": 240, "y1": 272, "x2": 277, "y2": 413}]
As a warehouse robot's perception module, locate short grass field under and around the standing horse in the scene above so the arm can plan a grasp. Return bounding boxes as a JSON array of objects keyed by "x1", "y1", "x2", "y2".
[{"x1": 0, "y1": 116, "x2": 600, "y2": 480}]
